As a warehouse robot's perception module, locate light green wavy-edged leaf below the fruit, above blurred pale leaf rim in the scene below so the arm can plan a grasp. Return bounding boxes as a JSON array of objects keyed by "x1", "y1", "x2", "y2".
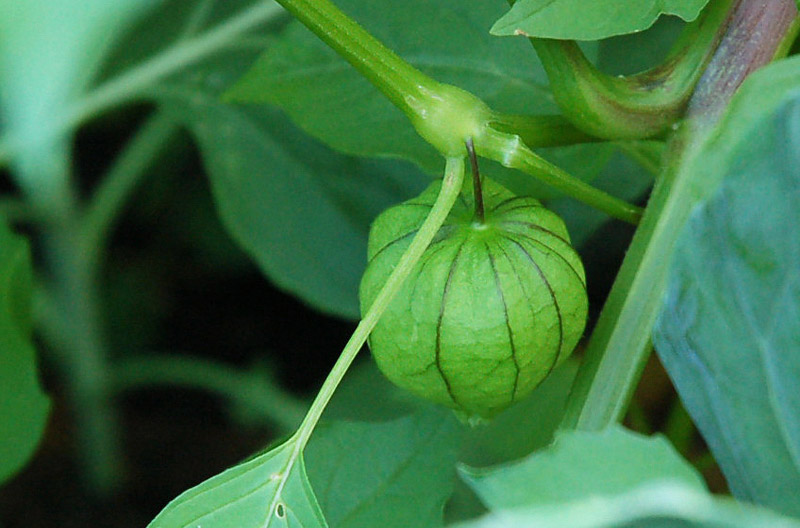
[{"x1": 461, "y1": 426, "x2": 705, "y2": 510}]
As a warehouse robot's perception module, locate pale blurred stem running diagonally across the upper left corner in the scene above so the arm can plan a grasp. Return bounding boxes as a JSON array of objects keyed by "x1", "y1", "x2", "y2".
[{"x1": 0, "y1": 2, "x2": 284, "y2": 166}]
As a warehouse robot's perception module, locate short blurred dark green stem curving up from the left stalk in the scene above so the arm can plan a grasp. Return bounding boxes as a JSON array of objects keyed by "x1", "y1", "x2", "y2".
[{"x1": 82, "y1": 112, "x2": 178, "y2": 269}]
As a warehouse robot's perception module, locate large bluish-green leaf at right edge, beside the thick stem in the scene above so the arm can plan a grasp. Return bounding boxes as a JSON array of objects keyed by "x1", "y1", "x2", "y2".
[{"x1": 654, "y1": 94, "x2": 800, "y2": 516}]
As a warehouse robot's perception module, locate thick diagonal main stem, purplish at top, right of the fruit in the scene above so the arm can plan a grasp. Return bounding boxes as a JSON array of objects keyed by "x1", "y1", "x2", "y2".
[{"x1": 561, "y1": 0, "x2": 797, "y2": 430}]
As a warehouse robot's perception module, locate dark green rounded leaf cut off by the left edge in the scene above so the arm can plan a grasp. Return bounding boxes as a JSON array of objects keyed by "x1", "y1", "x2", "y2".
[{"x1": 0, "y1": 221, "x2": 50, "y2": 483}]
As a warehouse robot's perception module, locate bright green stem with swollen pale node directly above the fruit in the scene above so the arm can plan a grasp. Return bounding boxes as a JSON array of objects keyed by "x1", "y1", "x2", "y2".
[{"x1": 278, "y1": 0, "x2": 641, "y2": 223}]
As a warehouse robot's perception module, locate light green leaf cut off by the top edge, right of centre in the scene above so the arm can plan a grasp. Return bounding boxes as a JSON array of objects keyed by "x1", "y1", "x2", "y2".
[{"x1": 491, "y1": 0, "x2": 708, "y2": 40}]
